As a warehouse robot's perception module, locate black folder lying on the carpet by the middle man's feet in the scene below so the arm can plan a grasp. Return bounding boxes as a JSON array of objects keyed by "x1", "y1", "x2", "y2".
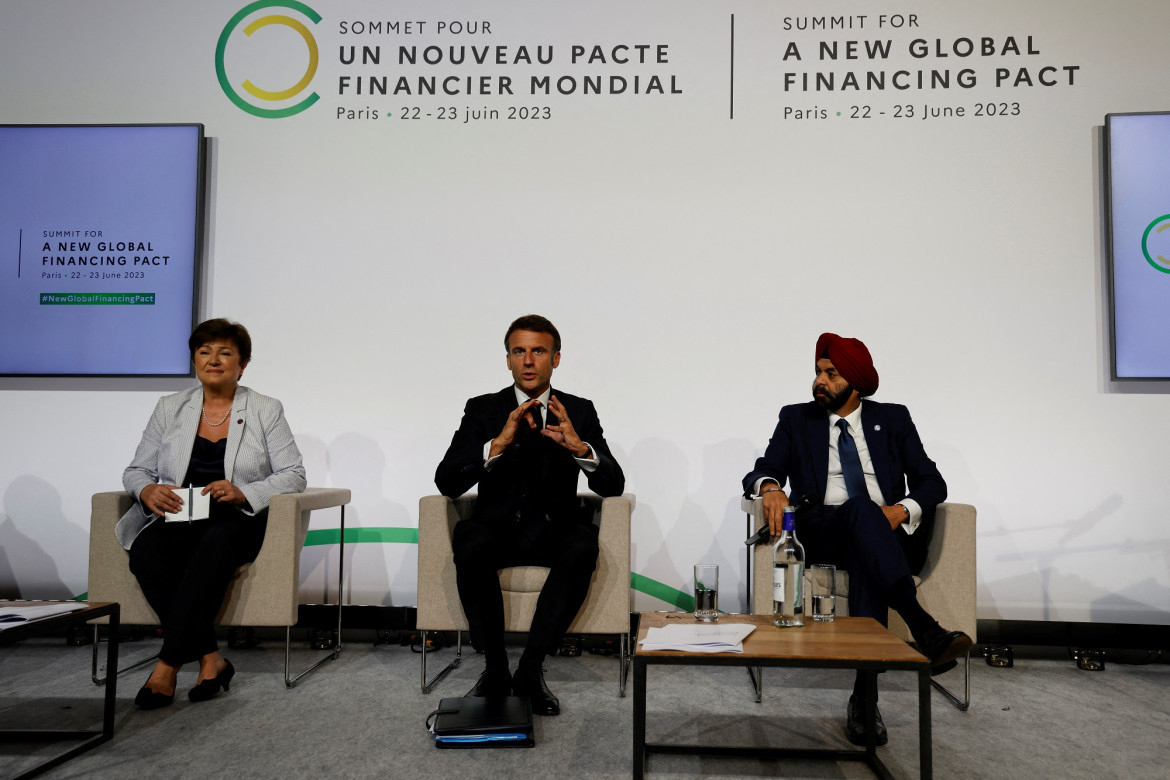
[{"x1": 428, "y1": 696, "x2": 536, "y2": 747}]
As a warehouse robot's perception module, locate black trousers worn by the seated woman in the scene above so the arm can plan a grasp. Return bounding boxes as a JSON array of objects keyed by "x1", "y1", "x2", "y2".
[{"x1": 130, "y1": 509, "x2": 268, "y2": 665}]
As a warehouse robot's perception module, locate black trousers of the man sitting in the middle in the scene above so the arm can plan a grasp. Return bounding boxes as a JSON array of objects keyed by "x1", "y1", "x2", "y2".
[{"x1": 452, "y1": 520, "x2": 598, "y2": 658}]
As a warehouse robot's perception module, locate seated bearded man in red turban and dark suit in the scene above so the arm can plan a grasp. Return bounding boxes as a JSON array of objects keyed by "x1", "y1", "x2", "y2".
[{"x1": 743, "y1": 333, "x2": 971, "y2": 745}]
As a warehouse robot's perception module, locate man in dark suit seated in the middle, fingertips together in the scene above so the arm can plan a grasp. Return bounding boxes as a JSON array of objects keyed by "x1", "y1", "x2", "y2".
[{"x1": 435, "y1": 315, "x2": 626, "y2": 715}]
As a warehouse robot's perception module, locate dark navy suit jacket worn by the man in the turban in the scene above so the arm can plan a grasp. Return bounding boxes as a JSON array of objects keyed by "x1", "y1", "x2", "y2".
[{"x1": 743, "y1": 400, "x2": 947, "y2": 572}]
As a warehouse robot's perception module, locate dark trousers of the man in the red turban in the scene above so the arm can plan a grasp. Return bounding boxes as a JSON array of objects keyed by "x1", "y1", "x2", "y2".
[{"x1": 797, "y1": 498, "x2": 913, "y2": 626}]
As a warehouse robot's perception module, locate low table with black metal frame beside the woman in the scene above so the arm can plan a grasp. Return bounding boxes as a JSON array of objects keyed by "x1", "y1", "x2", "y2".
[{"x1": 0, "y1": 601, "x2": 121, "y2": 779}]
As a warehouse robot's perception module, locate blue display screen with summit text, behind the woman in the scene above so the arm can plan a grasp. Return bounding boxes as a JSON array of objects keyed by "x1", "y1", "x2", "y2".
[{"x1": 0, "y1": 124, "x2": 204, "y2": 377}]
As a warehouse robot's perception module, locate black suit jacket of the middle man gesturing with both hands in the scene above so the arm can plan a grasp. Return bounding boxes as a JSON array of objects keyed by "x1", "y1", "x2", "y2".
[{"x1": 435, "y1": 386, "x2": 626, "y2": 524}]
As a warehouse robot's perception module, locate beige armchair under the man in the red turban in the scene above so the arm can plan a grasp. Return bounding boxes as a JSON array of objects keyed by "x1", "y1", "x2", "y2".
[{"x1": 742, "y1": 498, "x2": 976, "y2": 710}]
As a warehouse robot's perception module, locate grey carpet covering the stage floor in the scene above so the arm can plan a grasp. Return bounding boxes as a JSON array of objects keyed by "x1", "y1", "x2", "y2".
[{"x1": 0, "y1": 640, "x2": 1170, "y2": 780}]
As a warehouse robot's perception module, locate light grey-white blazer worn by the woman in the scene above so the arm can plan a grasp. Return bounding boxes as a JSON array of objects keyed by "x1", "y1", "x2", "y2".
[{"x1": 115, "y1": 385, "x2": 305, "y2": 550}]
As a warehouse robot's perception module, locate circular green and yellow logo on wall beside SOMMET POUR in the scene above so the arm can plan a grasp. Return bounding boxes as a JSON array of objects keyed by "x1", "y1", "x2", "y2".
[{"x1": 215, "y1": 0, "x2": 321, "y2": 119}]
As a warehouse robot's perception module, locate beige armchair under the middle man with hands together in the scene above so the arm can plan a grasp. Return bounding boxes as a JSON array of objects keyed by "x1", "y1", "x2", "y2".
[{"x1": 417, "y1": 493, "x2": 634, "y2": 696}]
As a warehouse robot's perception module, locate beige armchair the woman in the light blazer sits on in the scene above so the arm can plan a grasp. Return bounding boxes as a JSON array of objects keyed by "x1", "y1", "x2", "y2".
[{"x1": 87, "y1": 488, "x2": 350, "y2": 688}]
